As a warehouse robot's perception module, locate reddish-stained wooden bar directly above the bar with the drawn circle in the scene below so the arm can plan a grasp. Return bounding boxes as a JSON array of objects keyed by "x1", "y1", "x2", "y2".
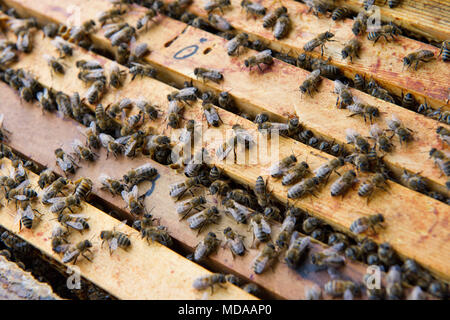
[{"x1": 169, "y1": 0, "x2": 450, "y2": 108}]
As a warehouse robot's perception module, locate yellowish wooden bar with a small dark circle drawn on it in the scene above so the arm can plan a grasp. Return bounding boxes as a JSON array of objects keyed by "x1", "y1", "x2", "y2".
[{"x1": 1, "y1": 0, "x2": 450, "y2": 196}]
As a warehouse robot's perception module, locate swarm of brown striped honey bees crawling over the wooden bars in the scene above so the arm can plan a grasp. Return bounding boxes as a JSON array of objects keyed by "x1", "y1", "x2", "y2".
[{"x1": 0, "y1": 0, "x2": 449, "y2": 299}]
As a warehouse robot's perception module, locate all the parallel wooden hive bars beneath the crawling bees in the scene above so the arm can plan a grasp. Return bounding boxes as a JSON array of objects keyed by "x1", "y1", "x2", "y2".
[{"x1": 0, "y1": 0, "x2": 450, "y2": 299}]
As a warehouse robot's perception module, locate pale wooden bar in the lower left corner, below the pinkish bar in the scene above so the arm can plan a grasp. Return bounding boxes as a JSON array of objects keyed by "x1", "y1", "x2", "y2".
[{"x1": 0, "y1": 159, "x2": 254, "y2": 300}]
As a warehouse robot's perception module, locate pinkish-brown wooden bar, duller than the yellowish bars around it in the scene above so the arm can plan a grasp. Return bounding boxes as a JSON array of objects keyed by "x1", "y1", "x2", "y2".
[{"x1": 0, "y1": 83, "x2": 378, "y2": 299}]
